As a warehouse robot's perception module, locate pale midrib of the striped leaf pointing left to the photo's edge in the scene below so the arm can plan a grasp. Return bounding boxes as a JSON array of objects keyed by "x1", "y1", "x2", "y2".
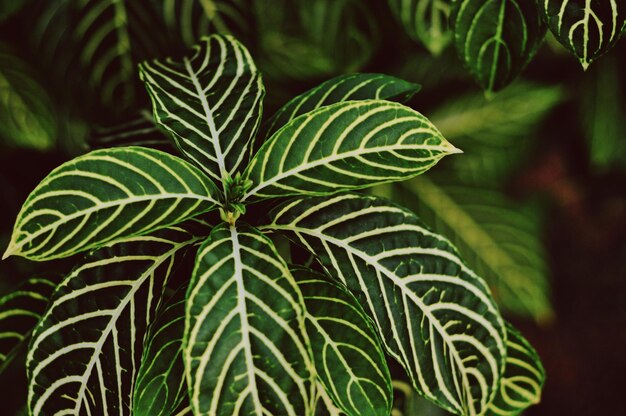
[{"x1": 2, "y1": 193, "x2": 217, "y2": 259}]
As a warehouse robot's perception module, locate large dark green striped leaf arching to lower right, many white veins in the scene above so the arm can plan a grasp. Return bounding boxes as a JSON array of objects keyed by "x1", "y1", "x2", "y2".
[{"x1": 267, "y1": 194, "x2": 505, "y2": 415}]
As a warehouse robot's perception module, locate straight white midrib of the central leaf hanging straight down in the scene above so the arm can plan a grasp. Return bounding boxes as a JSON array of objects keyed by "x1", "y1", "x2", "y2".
[{"x1": 230, "y1": 225, "x2": 263, "y2": 416}]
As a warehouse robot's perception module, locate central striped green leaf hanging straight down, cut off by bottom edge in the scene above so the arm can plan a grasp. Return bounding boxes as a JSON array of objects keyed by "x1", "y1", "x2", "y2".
[{"x1": 183, "y1": 224, "x2": 312, "y2": 416}]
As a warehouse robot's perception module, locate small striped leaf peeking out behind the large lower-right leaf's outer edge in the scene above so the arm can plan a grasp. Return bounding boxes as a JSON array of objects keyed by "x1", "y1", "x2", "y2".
[{"x1": 486, "y1": 323, "x2": 546, "y2": 416}]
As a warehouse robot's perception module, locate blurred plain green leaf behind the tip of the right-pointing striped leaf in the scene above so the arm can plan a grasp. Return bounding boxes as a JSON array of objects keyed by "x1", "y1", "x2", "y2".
[{"x1": 429, "y1": 81, "x2": 565, "y2": 185}]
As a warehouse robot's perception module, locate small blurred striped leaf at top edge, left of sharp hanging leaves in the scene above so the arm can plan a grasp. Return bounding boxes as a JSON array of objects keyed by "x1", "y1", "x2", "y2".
[{"x1": 389, "y1": 0, "x2": 454, "y2": 55}]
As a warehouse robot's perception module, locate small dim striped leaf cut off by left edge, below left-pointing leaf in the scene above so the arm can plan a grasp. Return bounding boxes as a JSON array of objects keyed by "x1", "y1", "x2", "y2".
[{"x1": 0, "y1": 276, "x2": 60, "y2": 373}]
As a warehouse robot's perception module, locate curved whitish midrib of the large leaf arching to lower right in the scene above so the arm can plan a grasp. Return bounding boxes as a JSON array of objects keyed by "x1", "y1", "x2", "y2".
[{"x1": 271, "y1": 224, "x2": 474, "y2": 411}]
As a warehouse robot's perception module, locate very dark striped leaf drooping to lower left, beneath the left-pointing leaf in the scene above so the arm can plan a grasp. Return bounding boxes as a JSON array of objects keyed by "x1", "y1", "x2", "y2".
[{"x1": 27, "y1": 227, "x2": 198, "y2": 415}]
